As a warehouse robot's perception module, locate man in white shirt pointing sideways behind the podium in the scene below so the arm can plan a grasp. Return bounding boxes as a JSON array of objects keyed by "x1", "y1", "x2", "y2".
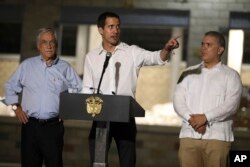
[{"x1": 83, "y1": 12, "x2": 179, "y2": 167}]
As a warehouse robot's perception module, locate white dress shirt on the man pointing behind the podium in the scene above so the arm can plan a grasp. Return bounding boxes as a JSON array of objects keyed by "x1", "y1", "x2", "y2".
[{"x1": 82, "y1": 42, "x2": 165, "y2": 97}]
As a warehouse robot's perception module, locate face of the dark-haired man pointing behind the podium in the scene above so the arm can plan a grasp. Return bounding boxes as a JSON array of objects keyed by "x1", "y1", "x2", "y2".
[{"x1": 98, "y1": 17, "x2": 120, "y2": 46}]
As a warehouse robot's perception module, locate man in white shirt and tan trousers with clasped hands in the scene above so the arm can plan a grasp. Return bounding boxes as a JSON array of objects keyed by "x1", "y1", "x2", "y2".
[{"x1": 174, "y1": 31, "x2": 242, "y2": 167}]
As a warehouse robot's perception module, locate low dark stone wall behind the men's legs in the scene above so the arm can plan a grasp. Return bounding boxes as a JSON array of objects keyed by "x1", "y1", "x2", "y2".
[{"x1": 0, "y1": 117, "x2": 250, "y2": 167}]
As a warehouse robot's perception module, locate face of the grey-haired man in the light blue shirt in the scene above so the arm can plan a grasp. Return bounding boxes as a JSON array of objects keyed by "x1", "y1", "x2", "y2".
[{"x1": 37, "y1": 32, "x2": 57, "y2": 60}]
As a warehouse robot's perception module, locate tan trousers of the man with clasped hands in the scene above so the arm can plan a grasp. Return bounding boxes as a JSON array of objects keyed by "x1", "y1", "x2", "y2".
[{"x1": 179, "y1": 138, "x2": 231, "y2": 167}]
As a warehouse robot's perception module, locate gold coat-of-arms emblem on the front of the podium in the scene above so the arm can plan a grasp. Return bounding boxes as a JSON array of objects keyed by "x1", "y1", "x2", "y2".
[{"x1": 85, "y1": 96, "x2": 103, "y2": 117}]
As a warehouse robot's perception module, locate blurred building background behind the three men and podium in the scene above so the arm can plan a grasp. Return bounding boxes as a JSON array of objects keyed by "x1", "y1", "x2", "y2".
[{"x1": 0, "y1": 0, "x2": 250, "y2": 167}]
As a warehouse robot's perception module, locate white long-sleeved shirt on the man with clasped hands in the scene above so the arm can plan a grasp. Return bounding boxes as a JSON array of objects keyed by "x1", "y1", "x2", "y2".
[{"x1": 174, "y1": 62, "x2": 242, "y2": 141}]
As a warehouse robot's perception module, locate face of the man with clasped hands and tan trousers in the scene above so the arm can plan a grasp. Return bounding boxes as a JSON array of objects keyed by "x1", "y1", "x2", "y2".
[{"x1": 201, "y1": 36, "x2": 224, "y2": 64}]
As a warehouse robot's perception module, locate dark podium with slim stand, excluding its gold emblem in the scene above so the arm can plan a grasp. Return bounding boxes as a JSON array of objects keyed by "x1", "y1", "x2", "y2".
[{"x1": 59, "y1": 92, "x2": 145, "y2": 167}]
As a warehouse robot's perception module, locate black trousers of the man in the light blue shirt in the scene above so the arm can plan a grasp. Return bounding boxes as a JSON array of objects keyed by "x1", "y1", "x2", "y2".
[{"x1": 21, "y1": 118, "x2": 64, "y2": 167}]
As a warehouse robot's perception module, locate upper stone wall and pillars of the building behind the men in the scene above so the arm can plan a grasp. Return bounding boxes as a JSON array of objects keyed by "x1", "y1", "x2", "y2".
[{"x1": 0, "y1": 0, "x2": 250, "y2": 65}]
